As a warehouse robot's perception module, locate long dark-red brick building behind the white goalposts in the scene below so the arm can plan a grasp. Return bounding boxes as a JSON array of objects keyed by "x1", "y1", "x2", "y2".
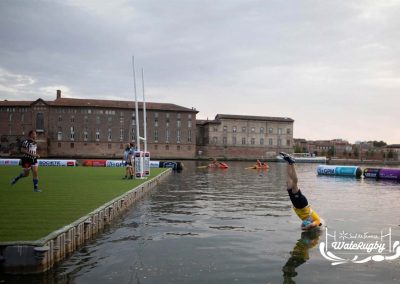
[{"x1": 0, "y1": 90, "x2": 198, "y2": 158}]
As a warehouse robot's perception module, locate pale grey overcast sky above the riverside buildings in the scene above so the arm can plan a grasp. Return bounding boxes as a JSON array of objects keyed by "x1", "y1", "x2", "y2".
[{"x1": 0, "y1": 0, "x2": 400, "y2": 144}]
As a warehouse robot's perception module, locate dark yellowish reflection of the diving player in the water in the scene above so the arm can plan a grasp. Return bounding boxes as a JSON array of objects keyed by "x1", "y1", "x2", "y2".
[{"x1": 282, "y1": 228, "x2": 321, "y2": 283}]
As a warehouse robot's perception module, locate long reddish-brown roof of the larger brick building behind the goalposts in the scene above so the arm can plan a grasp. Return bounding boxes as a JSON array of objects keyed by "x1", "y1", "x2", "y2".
[{"x1": 0, "y1": 98, "x2": 198, "y2": 113}]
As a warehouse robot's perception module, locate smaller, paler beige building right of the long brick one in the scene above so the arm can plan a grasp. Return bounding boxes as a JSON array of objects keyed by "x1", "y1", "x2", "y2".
[{"x1": 196, "y1": 114, "x2": 294, "y2": 159}]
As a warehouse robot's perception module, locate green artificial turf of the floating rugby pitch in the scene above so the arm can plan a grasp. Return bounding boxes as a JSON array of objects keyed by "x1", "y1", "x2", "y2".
[{"x1": 0, "y1": 166, "x2": 165, "y2": 242}]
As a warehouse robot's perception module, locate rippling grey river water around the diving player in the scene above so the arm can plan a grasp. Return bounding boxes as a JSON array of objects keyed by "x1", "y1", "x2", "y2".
[{"x1": 6, "y1": 162, "x2": 400, "y2": 284}]
